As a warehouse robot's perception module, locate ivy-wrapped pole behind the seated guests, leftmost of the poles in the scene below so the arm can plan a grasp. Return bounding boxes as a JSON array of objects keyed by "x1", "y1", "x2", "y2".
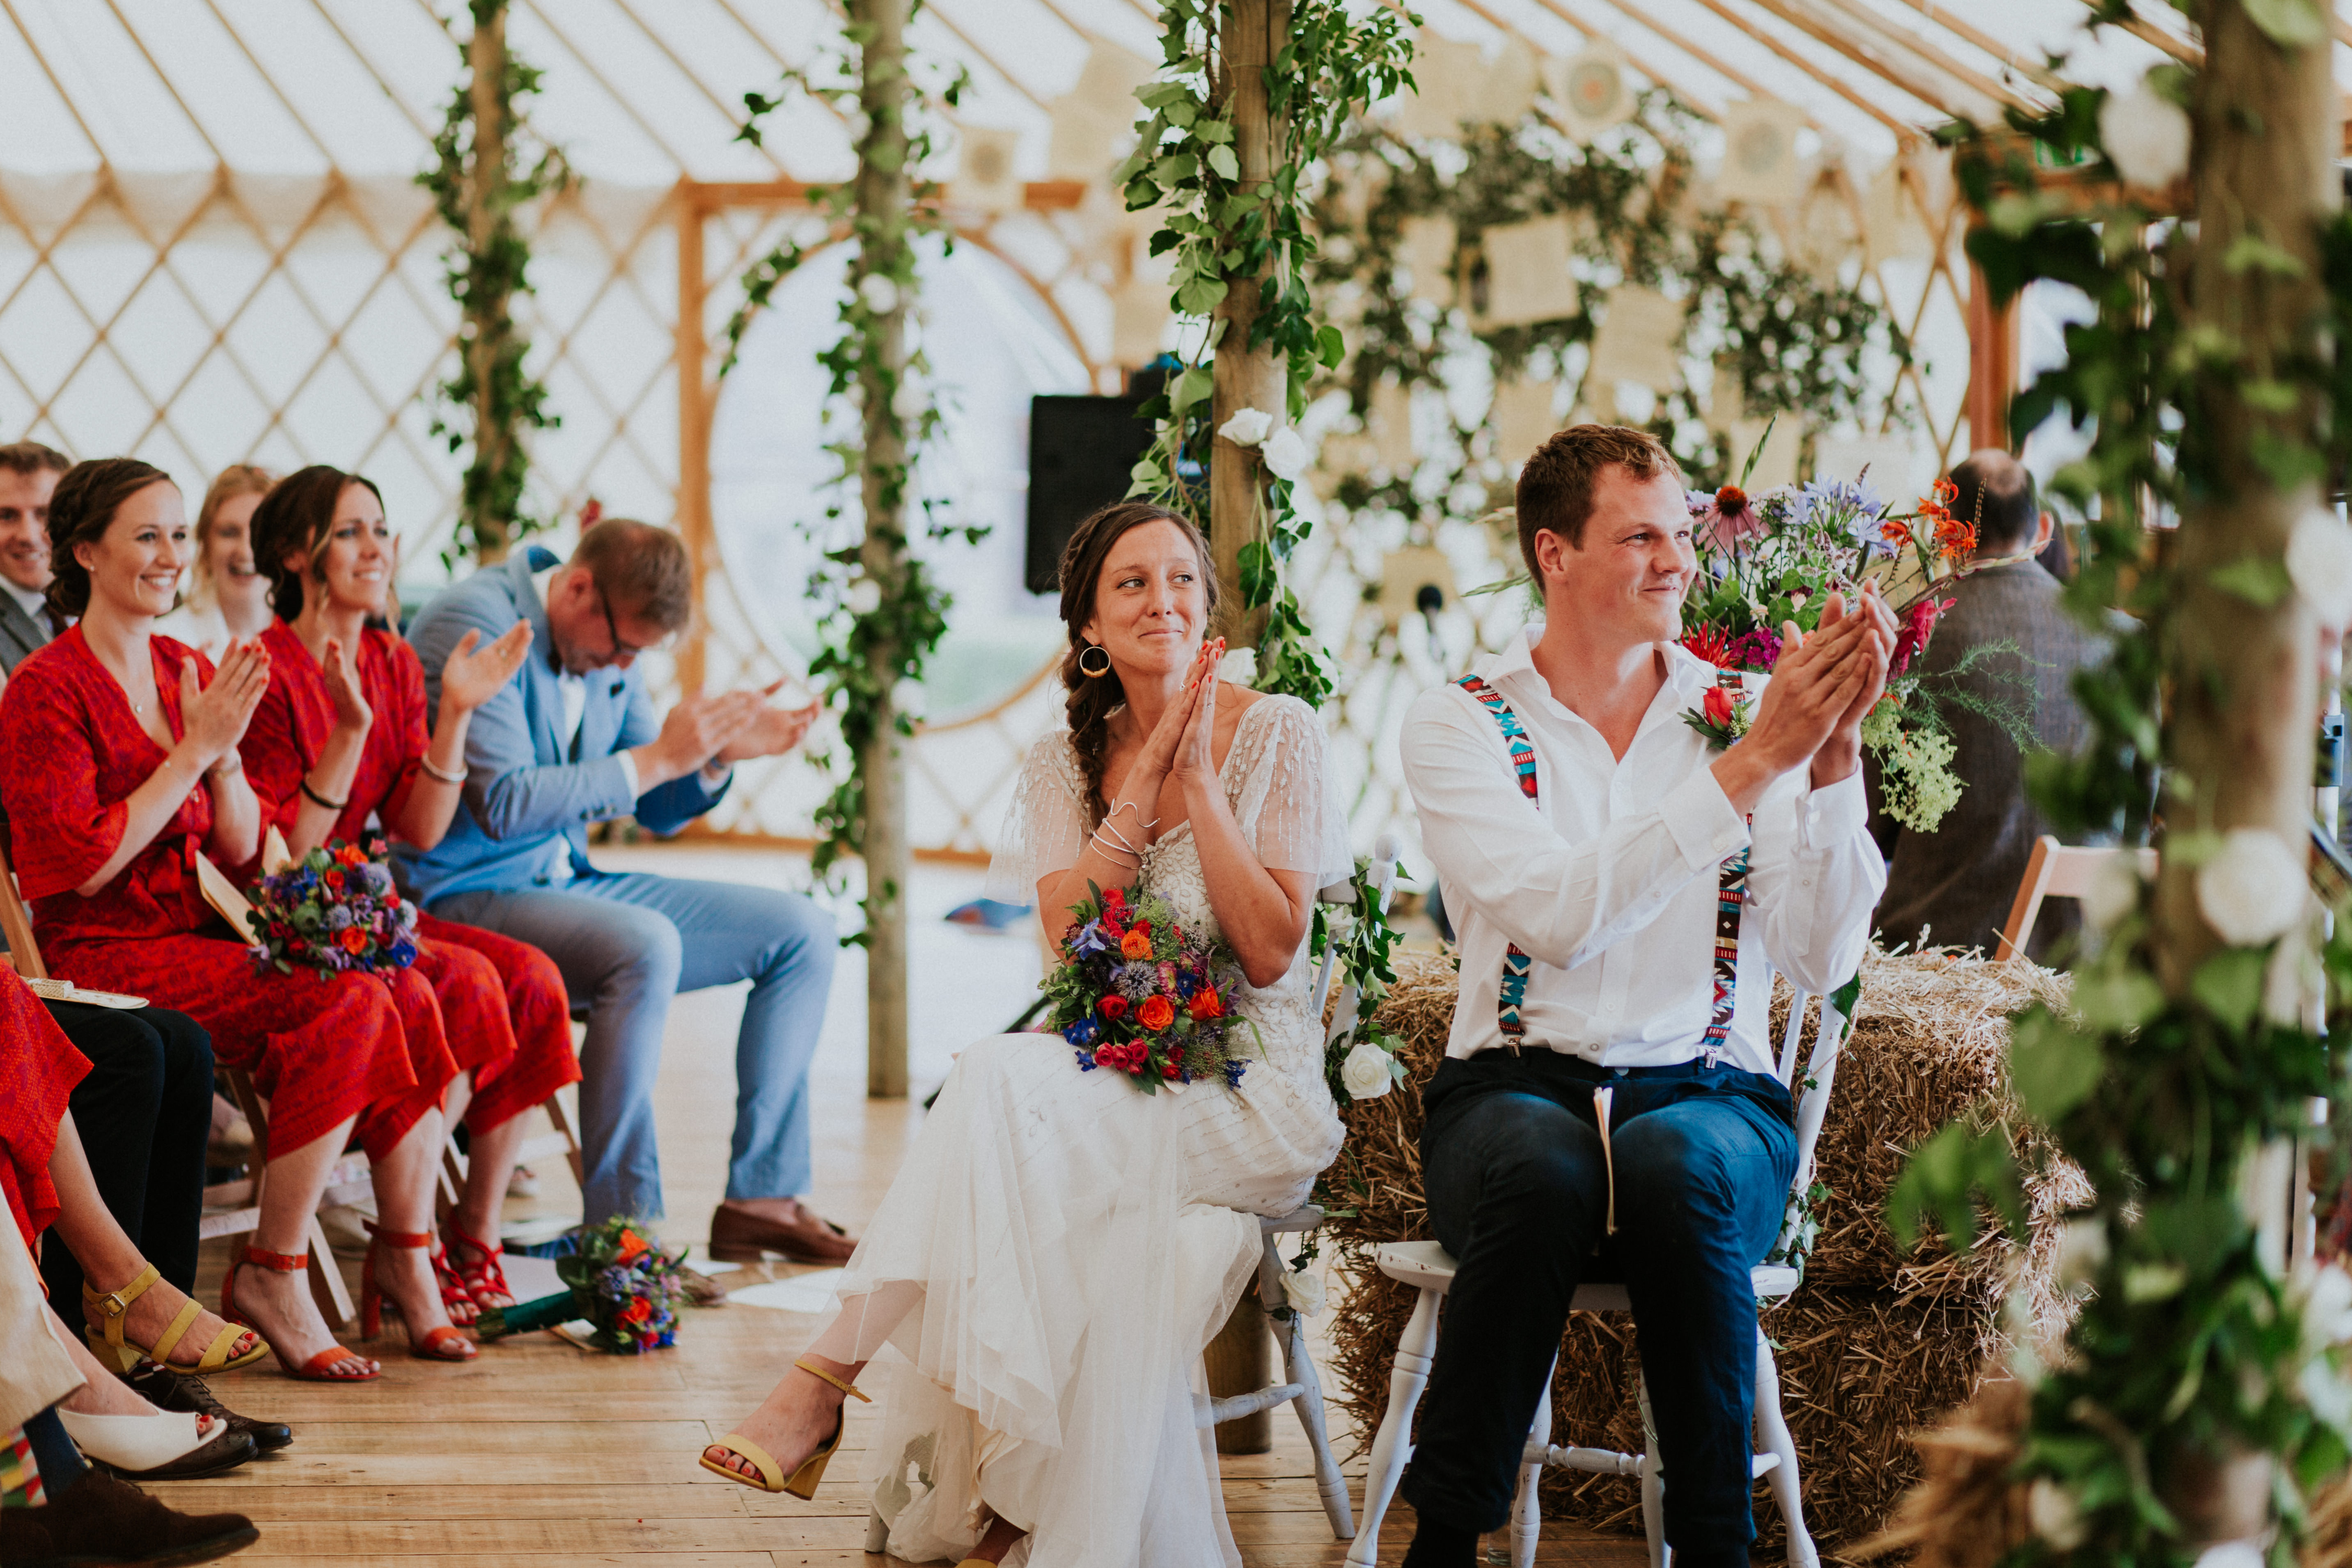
[{"x1": 416, "y1": 0, "x2": 576, "y2": 566}]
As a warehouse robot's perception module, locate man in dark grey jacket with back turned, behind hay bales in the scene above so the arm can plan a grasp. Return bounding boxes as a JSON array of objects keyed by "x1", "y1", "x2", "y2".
[{"x1": 1875, "y1": 447, "x2": 2105, "y2": 959}]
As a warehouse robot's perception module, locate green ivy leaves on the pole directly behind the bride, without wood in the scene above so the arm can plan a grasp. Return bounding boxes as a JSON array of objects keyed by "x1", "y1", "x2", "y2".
[{"x1": 1115, "y1": 0, "x2": 1421, "y2": 708}]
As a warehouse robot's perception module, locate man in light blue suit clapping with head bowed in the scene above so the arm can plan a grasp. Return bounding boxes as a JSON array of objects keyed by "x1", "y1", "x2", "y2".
[{"x1": 397, "y1": 520, "x2": 851, "y2": 1262}]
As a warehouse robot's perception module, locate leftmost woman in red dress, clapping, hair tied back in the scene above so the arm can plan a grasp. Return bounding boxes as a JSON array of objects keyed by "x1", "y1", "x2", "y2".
[{"x1": 0, "y1": 458, "x2": 473, "y2": 1382}]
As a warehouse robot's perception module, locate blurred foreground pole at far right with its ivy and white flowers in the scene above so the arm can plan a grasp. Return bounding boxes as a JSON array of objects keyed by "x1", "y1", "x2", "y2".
[{"x1": 1889, "y1": 0, "x2": 2352, "y2": 1563}]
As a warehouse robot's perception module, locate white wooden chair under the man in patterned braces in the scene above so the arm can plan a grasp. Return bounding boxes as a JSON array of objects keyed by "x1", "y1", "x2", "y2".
[{"x1": 1348, "y1": 992, "x2": 1844, "y2": 1568}]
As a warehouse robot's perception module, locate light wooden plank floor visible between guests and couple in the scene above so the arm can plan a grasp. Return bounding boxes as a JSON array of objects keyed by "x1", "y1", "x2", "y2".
[{"x1": 138, "y1": 851, "x2": 1646, "y2": 1568}]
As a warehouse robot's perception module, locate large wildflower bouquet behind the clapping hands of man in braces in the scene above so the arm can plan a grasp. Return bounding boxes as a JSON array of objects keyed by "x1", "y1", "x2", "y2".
[{"x1": 1682, "y1": 442, "x2": 2032, "y2": 832}]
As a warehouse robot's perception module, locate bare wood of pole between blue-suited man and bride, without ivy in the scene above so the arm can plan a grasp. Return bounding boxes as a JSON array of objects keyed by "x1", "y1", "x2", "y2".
[{"x1": 849, "y1": 0, "x2": 908, "y2": 1100}]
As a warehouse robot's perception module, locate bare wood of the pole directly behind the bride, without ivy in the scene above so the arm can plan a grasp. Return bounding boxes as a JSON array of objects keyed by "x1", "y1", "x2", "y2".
[{"x1": 1209, "y1": 0, "x2": 1291, "y2": 649}]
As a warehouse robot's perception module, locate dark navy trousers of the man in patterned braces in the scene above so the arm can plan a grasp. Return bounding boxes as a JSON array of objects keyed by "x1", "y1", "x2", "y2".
[{"x1": 1404, "y1": 1046, "x2": 1797, "y2": 1568}]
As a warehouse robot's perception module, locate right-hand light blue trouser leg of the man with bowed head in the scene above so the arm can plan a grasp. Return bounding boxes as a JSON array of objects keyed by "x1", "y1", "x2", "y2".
[{"x1": 574, "y1": 872, "x2": 840, "y2": 1199}]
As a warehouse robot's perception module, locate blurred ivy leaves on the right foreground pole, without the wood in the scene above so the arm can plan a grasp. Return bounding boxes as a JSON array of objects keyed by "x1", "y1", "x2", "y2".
[{"x1": 1889, "y1": 0, "x2": 2352, "y2": 1563}]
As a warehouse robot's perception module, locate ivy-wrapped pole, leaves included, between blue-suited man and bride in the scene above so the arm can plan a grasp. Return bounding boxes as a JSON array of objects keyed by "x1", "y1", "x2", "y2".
[{"x1": 722, "y1": 0, "x2": 988, "y2": 1098}]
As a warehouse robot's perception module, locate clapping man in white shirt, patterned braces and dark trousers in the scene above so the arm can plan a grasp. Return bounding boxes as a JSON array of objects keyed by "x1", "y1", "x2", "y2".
[{"x1": 1404, "y1": 426, "x2": 1894, "y2": 1568}]
